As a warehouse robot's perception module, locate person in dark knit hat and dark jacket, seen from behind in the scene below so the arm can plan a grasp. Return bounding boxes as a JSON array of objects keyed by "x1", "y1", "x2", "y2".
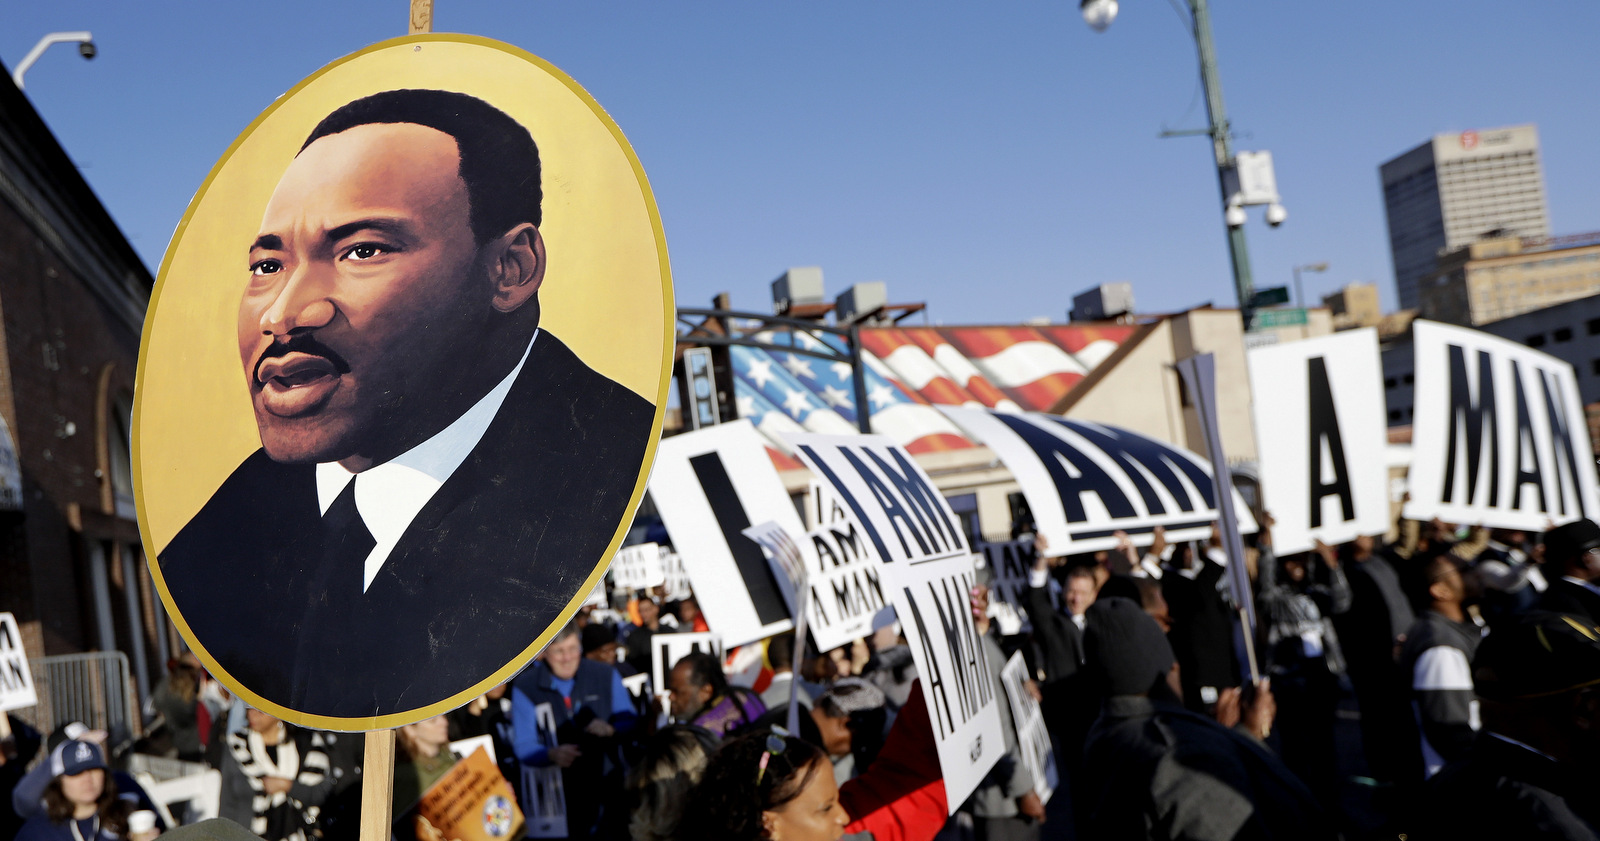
[{"x1": 1074, "y1": 598, "x2": 1336, "y2": 841}]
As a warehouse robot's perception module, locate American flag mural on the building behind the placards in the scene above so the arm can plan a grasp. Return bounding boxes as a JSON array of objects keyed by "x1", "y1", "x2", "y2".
[{"x1": 730, "y1": 323, "x2": 1138, "y2": 468}]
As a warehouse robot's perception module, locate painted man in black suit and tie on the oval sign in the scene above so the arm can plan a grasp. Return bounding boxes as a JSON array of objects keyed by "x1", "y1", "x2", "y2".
[{"x1": 160, "y1": 90, "x2": 654, "y2": 719}]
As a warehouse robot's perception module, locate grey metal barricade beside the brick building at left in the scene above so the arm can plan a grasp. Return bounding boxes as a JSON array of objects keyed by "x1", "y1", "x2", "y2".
[{"x1": 11, "y1": 651, "x2": 142, "y2": 739}]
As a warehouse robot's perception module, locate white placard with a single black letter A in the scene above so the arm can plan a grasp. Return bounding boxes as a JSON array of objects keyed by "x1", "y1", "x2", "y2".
[{"x1": 1248, "y1": 328, "x2": 1389, "y2": 555}]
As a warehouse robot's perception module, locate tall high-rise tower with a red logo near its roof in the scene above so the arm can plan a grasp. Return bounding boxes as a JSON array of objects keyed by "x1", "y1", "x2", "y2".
[{"x1": 1379, "y1": 125, "x2": 1550, "y2": 316}]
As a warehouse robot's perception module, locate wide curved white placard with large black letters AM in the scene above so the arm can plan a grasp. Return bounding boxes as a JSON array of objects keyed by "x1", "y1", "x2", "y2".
[{"x1": 939, "y1": 406, "x2": 1256, "y2": 556}]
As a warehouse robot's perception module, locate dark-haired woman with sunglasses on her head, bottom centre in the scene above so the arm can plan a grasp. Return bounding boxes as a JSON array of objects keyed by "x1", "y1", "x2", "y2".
[{"x1": 678, "y1": 726, "x2": 850, "y2": 841}]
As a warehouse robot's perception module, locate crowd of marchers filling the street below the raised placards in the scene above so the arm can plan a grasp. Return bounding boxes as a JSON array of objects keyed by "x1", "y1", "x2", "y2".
[{"x1": 0, "y1": 516, "x2": 1600, "y2": 841}]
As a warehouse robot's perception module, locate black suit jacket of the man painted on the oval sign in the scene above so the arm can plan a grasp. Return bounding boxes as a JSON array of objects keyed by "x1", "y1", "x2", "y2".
[{"x1": 160, "y1": 331, "x2": 654, "y2": 718}]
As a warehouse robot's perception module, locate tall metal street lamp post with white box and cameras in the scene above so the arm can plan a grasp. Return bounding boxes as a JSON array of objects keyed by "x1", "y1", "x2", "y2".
[{"x1": 1078, "y1": 0, "x2": 1288, "y2": 329}]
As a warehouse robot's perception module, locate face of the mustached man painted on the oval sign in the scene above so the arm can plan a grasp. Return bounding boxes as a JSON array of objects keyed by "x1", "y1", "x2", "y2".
[{"x1": 238, "y1": 123, "x2": 542, "y2": 470}]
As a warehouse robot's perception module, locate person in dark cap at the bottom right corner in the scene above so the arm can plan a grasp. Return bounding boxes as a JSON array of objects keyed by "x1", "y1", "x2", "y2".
[{"x1": 1408, "y1": 611, "x2": 1600, "y2": 841}]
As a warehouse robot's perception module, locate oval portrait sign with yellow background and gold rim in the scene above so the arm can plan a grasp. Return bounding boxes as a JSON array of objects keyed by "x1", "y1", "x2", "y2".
[{"x1": 134, "y1": 35, "x2": 674, "y2": 731}]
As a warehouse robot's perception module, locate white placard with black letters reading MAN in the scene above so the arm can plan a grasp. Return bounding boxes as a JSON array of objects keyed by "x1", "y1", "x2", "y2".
[{"x1": 1405, "y1": 321, "x2": 1600, "y2": 531}]
